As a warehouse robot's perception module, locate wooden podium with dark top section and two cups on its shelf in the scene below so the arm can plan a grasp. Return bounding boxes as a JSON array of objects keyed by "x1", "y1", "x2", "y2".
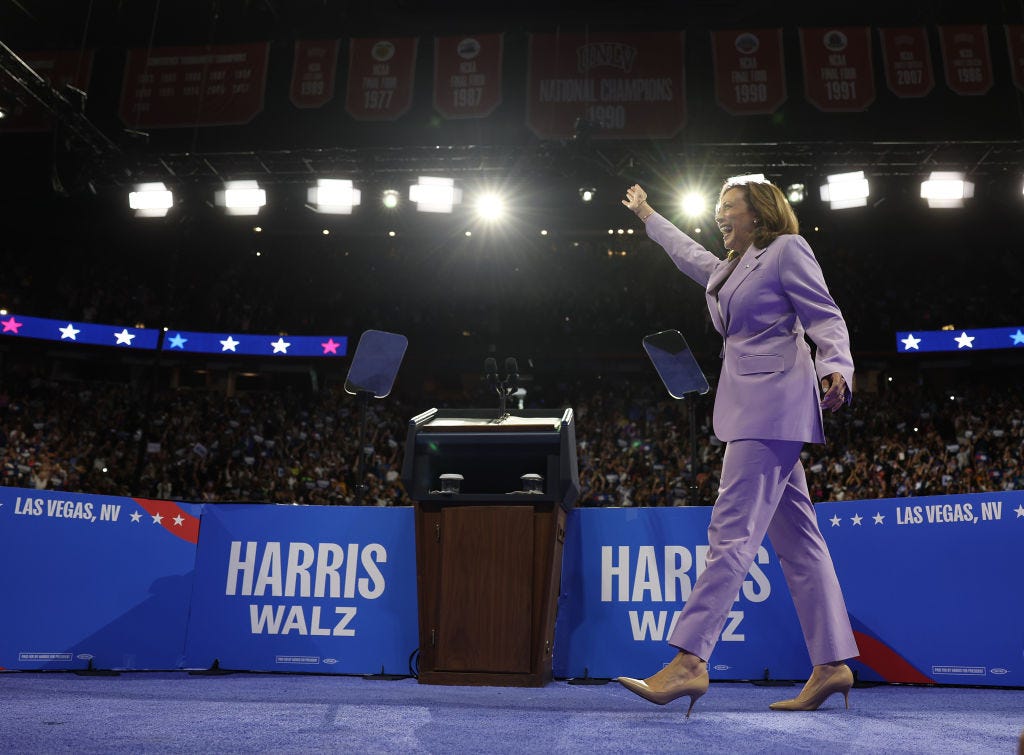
[{"x1": 402, "y1": 409, "x2": 580, "y2": 686}]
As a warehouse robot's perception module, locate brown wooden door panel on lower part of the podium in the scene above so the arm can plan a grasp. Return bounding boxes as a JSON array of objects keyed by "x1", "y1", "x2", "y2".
[{"x1": 435, "y1": 506, "x2": 534, "y2": 673}]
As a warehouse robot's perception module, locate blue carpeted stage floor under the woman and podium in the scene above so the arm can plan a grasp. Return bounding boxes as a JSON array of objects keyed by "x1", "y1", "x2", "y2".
[{"x1": 0, "y1": 672, "x2": 1024, "y2": 753}]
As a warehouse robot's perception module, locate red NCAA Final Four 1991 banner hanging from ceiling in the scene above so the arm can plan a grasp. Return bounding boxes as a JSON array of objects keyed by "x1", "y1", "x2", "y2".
[{"x1": 800, "y1": 27, "x2": 874, "y2": 113}]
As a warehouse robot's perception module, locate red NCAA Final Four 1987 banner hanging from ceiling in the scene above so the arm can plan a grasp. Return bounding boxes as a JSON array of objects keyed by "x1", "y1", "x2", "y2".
[{"x1": 434, "y1": 34, "x2": 503, "y2": 118}]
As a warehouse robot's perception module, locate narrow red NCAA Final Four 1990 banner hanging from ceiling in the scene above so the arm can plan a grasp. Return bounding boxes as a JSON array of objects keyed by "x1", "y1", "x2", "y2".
[{"x1": 711, "y1": 29, "x2": 786, "y2": 116}]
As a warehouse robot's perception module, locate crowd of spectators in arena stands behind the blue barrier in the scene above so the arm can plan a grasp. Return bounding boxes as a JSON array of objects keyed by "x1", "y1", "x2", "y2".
[{"x1": 0, "y1": 355, "x2": 1024, "y2": 506}]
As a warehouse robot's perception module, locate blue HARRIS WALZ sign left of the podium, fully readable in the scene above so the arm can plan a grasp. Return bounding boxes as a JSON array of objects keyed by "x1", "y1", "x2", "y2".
[{"x1": 185, "y1": 504, "x2": 419, "y2": 674}]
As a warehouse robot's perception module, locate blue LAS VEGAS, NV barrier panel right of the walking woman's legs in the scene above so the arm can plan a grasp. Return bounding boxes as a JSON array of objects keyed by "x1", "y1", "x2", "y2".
[{"x1": 817, "y1": 491, "x2": 1024, "y2": 686}]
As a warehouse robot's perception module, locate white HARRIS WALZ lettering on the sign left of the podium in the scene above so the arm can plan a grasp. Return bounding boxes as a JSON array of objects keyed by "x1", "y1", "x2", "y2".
[{"x1": 224, "y1": 540, "x2": 387, "y2": 637}]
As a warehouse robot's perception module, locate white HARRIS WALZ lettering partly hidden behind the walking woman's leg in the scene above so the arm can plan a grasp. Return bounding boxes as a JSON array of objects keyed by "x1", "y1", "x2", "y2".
[{"x1": 601, "y1": 545, "x2": 771, "y2": 642}]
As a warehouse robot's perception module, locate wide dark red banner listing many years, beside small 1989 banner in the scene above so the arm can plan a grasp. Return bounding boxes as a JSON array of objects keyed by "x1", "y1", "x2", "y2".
[{"x1": 119, "y1": 42, "x2": 270, "y2": 128}]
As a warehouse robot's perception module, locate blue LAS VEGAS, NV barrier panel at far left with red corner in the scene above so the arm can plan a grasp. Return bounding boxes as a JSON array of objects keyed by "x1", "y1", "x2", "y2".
[{"x1": 0, "y1": 488, "x2": 202, "y2": 670}]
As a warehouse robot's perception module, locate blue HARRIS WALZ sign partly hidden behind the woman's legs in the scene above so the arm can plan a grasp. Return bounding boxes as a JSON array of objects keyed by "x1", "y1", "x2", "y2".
[{"x1": 554, "y1": 507, "x2": 810, "y2": 679}]
